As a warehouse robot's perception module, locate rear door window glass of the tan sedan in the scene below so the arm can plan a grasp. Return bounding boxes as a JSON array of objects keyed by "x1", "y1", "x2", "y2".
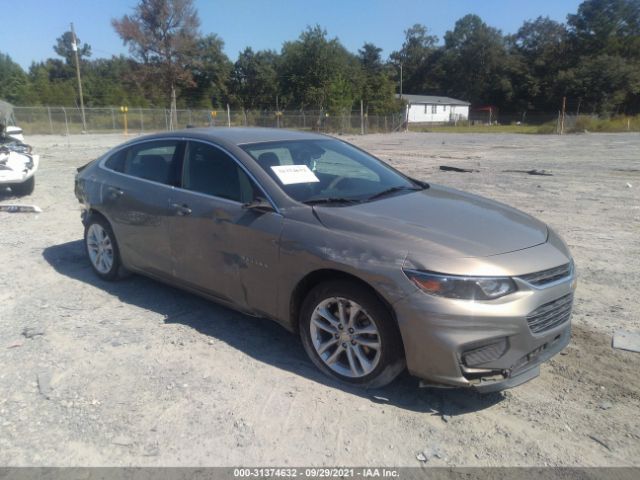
[{"x1": 124, "y1": 140, "x2": 180, "y2": 186}]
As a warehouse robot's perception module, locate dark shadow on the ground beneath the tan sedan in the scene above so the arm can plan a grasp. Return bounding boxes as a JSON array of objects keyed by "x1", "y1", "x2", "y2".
[{"x1": 43, "y1": 240, "x2": 504, "y2": 419}]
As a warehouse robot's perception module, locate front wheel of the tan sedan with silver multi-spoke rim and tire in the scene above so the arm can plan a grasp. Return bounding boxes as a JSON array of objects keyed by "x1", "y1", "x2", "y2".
[{"x1": 299, "y1": 280, "x2": 405, "y2": 388}]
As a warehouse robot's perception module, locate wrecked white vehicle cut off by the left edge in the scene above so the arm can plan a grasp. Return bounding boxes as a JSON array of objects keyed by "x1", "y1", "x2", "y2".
[{"x1": 0, "y1": 141, "x2": 40, "y2": 196}]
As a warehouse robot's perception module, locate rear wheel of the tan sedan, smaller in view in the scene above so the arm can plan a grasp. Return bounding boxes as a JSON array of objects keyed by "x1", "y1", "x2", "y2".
[{"x1": 84, "y1": 215, "x2": 122, "y2": 281}]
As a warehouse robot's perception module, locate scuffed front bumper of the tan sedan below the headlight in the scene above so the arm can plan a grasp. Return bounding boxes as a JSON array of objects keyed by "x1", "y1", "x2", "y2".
[{"x1": 394, "y1": 258, "x2": 575, "y2": 392}]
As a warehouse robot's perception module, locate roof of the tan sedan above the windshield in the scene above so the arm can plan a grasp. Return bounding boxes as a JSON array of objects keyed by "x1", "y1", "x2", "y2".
[{"x1": 155, "y1": 127, "x2": 327, "y2": 145}]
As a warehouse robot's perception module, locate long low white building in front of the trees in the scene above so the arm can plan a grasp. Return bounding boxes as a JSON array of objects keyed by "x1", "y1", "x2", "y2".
[{"x1": 396, "y1": 95, "x2": 471, "y2": 123}]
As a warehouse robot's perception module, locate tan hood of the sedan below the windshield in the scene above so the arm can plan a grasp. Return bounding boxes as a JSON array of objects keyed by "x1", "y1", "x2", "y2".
[{"x1": 314, "y1": 185, "x2": 548, "y2": 258}]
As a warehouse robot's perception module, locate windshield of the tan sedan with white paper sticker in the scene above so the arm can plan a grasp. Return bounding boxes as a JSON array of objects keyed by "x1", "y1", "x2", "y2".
[{"x1": 242, "y1": 139, "x2": 422, "y2": 205}]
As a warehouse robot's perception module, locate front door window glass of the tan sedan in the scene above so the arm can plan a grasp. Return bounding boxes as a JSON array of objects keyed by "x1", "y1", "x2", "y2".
[{"x1": 182, "y1": 142, "x2": 258, "y2": 203}]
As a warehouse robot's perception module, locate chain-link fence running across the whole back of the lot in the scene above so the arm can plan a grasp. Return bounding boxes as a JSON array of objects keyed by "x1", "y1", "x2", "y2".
[{"x1": 13, "y1": 107, "x2": 640, "y2": 135}]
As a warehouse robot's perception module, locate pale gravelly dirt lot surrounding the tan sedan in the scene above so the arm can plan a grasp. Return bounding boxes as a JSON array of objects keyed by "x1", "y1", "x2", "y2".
[{"x1": 0, "y1": 133, "x2": 640, "y2": 466}]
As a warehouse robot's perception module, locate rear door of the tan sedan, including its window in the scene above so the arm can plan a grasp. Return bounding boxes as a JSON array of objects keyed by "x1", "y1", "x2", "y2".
[{"x1": 102, "y1": 140, "x2": 184, "y2": 278}]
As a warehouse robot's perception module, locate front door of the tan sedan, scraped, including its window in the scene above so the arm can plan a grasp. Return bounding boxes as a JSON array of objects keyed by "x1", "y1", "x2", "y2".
[{"x1": 171, "y1": 141, "x2": 282, "y2": 315}]
